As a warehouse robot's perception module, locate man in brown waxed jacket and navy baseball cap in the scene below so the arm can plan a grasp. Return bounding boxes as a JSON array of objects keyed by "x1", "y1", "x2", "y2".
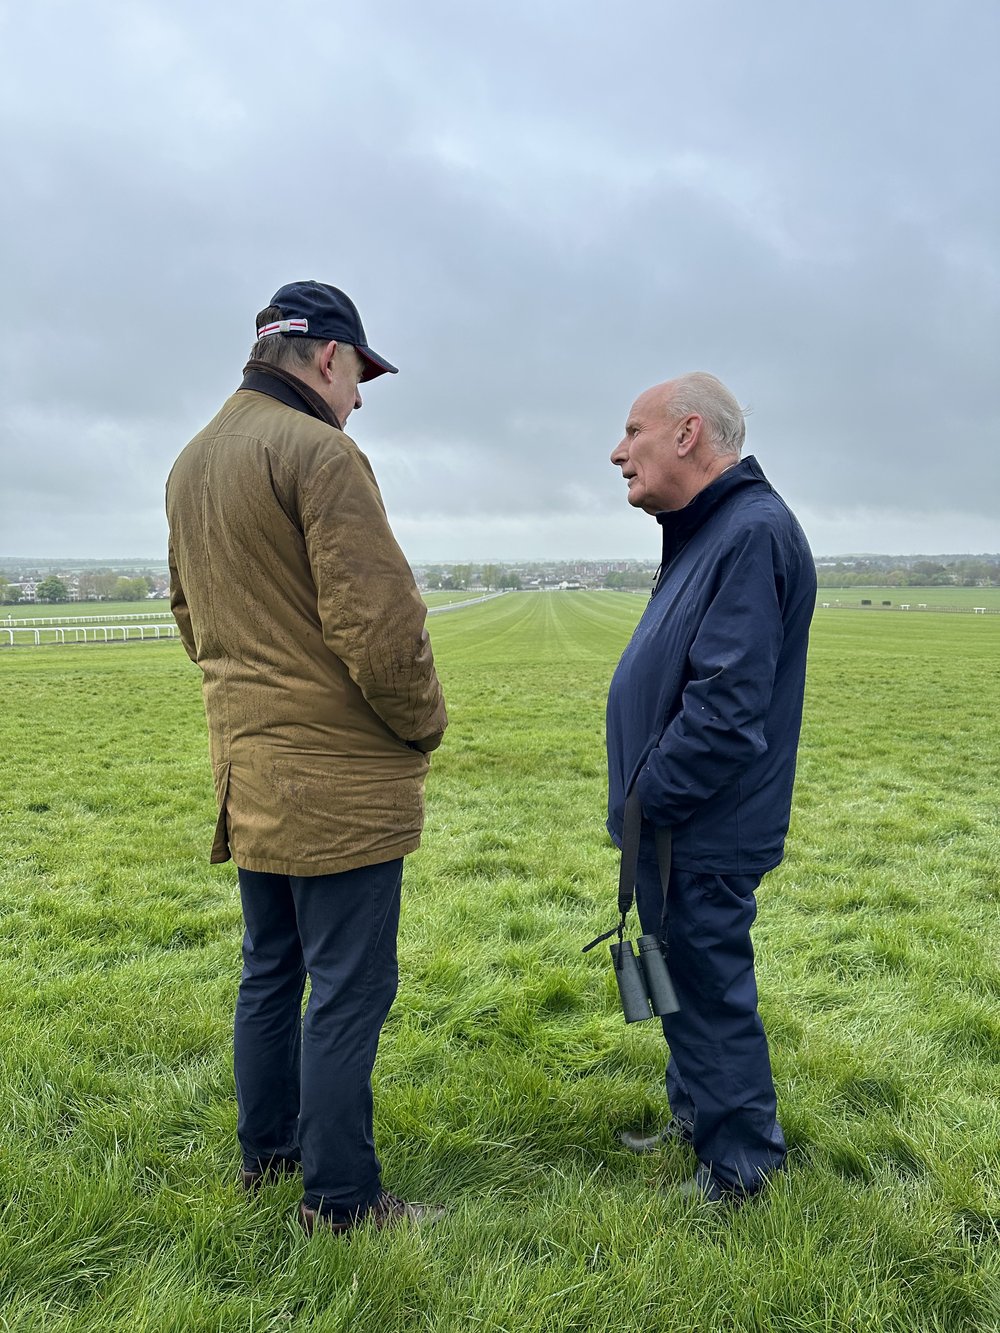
[{"x1": 167, "y1": 283, "x2": 447, "y2": 1232}]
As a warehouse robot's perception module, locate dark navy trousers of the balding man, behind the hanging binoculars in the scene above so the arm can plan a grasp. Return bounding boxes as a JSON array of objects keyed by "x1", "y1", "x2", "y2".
[{"x1": 636, "y1": 860, "x2": 785, "y2": 1193}]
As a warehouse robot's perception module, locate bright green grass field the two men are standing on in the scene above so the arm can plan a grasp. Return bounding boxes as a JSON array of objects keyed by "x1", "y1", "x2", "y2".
[{"x1": 0, "y1": 592, "x2": 1000, "y2": 1333}]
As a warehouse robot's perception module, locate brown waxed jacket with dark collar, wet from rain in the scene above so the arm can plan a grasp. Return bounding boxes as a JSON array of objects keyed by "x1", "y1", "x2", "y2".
[{"x1": 167, "y1": 388, "x2": 447, "y2": 874}]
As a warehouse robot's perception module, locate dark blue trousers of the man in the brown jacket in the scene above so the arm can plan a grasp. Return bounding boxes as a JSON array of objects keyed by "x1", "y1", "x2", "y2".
[{"x1": 235, "y1": 860, "x2": 403, "y2": 1216}]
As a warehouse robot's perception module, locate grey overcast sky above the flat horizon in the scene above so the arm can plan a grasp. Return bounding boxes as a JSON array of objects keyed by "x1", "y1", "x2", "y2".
[{"x1": 0, "y1": 0, "x2": 1000, "y2": 561}]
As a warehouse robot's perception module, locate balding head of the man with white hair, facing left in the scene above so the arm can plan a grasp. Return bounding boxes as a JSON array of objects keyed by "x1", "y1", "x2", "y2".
[{"x1": 611, "y1": 371, "x2": 745, "y2": 513}]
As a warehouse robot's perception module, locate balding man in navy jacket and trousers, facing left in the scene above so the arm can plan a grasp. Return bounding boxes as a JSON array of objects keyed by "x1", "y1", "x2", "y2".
[{"x1": 608, "y1": 373, "x2": 816, "y2": 1201}]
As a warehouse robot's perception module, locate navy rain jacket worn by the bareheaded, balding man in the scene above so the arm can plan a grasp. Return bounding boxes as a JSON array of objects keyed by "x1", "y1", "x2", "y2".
[{"x1": 608, "y1": 456, "x2": 816, "y2": 874}]
